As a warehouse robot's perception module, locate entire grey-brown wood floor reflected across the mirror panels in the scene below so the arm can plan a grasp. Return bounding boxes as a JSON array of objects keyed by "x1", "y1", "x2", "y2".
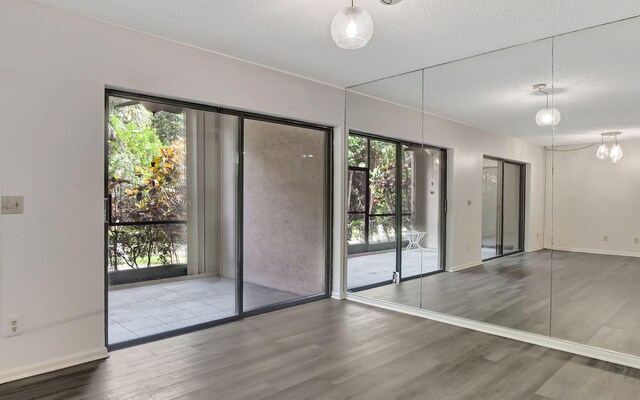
[{"x1": 358, "y1": 250, "x2": 640, "y2": 356}]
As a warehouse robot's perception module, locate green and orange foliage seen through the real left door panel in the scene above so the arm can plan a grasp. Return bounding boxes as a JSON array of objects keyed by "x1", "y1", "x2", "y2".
[{"x1": 108, "y1": 97, "x2": 187, "y2": 270}]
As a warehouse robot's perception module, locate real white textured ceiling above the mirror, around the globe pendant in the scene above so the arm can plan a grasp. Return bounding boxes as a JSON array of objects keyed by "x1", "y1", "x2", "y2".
[{"x1": 34, "y1": 0, "x2": 640, "y2": 87}]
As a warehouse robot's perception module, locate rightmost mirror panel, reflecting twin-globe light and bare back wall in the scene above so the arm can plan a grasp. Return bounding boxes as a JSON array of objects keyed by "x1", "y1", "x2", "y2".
[{"x1": 545, "y1": 18, "x2": 640, "y2": 356}]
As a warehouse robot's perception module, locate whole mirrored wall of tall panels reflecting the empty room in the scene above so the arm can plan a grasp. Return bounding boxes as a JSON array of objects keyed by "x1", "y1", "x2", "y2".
[{"x1": 346, "y1": 18, "x2": 640, "y2": 356}]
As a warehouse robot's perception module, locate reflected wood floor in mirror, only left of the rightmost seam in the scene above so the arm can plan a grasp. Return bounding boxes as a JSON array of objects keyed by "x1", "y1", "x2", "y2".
[{"x1": 358, "y1": 250, "x2": 551, "y2": 335}]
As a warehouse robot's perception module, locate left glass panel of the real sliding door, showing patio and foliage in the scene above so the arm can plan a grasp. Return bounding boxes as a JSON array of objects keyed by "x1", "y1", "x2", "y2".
[{"x1": 105, "y1": 92, "x2": 238, "y2": 346}]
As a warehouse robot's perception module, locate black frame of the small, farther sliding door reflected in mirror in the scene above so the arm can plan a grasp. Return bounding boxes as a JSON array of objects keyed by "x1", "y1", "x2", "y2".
[{"x1": 480, "y1": 155, "x2": 527, "y2": 261}]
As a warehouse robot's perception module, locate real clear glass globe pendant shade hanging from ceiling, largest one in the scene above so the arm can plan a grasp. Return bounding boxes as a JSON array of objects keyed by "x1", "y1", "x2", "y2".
[{"x1": 331, "y1": 7, "x2": 373, "y2": 49}]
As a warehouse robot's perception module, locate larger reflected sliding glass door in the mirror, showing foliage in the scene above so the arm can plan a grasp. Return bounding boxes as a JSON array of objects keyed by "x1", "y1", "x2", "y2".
[{"x1": 347, "y1": 133, "x2": 445, "y2": 290}]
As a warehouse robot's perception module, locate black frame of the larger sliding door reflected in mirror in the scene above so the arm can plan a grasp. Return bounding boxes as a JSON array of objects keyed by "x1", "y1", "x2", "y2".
[{"x1": 346, "y1": 129, "x2": 447, "y2": 293}]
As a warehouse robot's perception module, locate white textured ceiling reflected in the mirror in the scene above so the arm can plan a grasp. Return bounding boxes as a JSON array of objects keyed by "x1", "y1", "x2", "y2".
[{"x1": 351, "y1": 18, "x2": 640, "y2": 145}]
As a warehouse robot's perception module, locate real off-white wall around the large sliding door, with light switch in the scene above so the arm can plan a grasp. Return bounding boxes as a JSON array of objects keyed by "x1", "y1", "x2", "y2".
[{"x1": 0, "y1": 0, "x2": 344, "y2": 382}]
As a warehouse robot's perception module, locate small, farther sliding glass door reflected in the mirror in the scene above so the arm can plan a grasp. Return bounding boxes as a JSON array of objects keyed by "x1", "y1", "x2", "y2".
[{"x1": 482, "y1": 157, "x2": 525, "y2": 260}]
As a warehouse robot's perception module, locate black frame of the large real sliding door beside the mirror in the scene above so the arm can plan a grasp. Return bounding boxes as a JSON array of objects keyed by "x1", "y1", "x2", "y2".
[{"x1": 103, "y1": 88, "x2": 334, "y2": 351}]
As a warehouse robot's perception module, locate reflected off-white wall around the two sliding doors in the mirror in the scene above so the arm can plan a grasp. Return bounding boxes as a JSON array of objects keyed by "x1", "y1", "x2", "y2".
[{"x1": 347, "y1": 92, "x2": 544, "y2": 270}]
